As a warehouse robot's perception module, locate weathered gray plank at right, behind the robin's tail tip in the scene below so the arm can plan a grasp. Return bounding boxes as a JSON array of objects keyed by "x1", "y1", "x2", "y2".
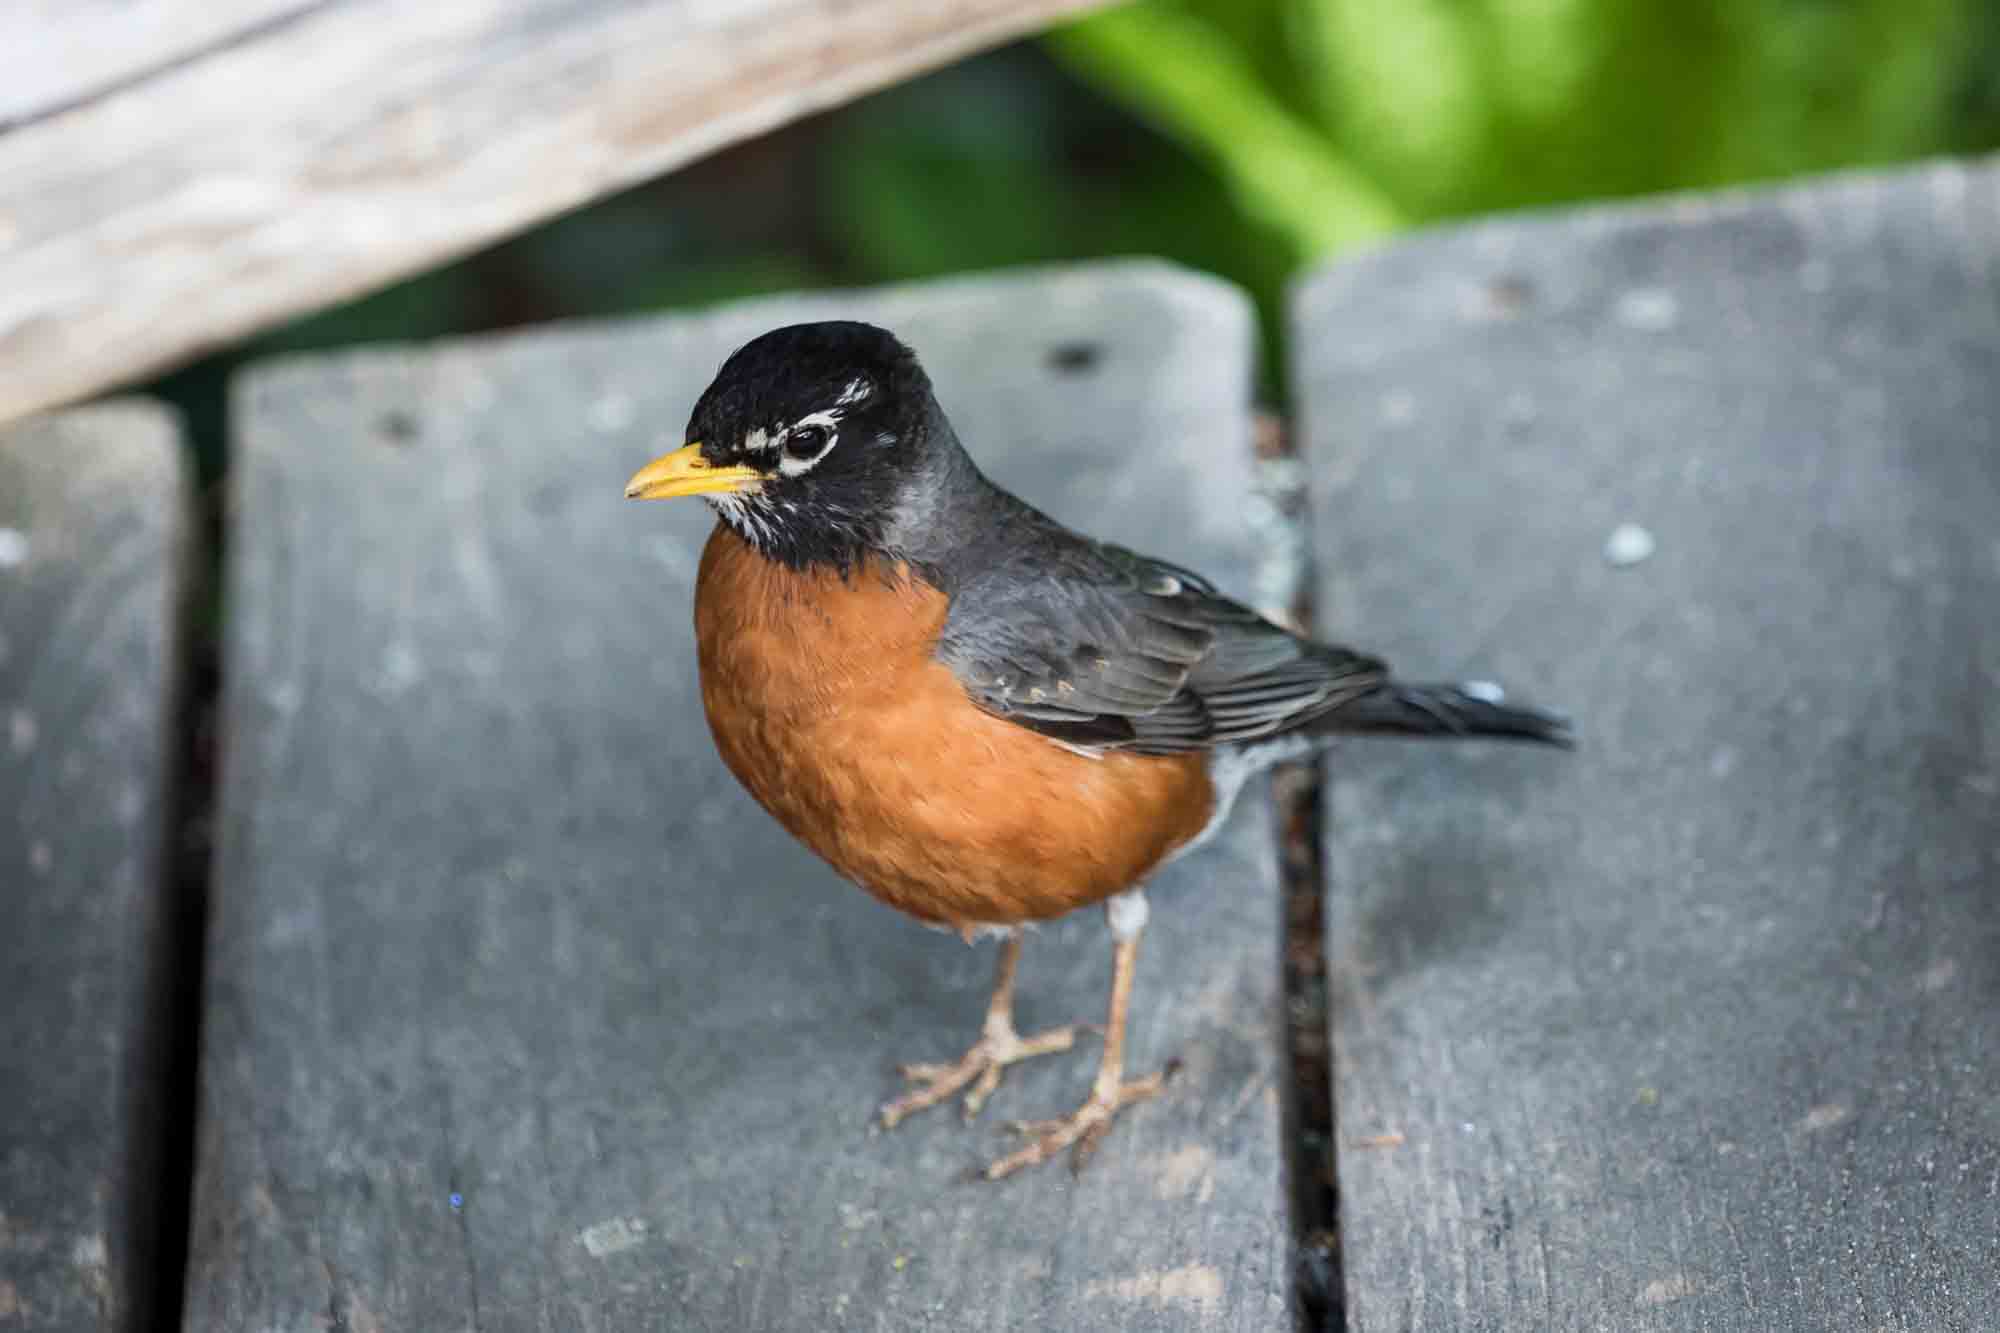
[{"x1": 1298, "y1": 166, "x2": 2000, "y2": 1331}]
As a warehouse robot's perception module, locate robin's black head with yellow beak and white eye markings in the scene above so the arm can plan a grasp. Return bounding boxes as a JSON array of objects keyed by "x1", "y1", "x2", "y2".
[{"x1": 626, "y1": 320, "x2": 956, "y2": 568}]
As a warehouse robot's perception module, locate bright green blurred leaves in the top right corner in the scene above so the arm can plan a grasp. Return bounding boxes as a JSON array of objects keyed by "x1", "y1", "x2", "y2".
[{"x1": 1050, "y1": 0, "x2": 2000, "y2": 260}]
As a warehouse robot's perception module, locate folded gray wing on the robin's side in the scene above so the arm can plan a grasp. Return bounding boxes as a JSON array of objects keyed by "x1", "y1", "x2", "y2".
[{"x1": 938, "y1": 538, "x2": 1388, "y2": 755}]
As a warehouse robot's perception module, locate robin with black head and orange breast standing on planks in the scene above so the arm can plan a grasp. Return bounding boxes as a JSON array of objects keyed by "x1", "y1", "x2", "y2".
[{"x1": 626, "y1": 320, "x2": 1570, "y2": 1179}]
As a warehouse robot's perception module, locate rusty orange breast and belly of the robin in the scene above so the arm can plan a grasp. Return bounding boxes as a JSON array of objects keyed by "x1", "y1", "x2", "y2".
[{"x1": 694, "y1": 524, "x2": 1214, "y2": 927}]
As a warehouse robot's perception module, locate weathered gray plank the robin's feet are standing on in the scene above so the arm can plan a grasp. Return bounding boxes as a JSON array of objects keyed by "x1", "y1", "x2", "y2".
[{"x1": 190, "y1": 266, "x2": 1288, "y2": 1331}]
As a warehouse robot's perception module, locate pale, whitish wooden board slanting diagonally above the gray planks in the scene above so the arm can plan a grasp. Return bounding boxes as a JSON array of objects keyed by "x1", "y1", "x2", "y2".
[{"x1": 0, "y1": 0, "x2": 1100, "y2": 420}]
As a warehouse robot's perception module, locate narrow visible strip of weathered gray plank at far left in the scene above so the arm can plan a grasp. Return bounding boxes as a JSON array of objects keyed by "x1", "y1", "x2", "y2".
[{"x1": 0, "y1": 402, "x2": 188, "y2": 1329}]
